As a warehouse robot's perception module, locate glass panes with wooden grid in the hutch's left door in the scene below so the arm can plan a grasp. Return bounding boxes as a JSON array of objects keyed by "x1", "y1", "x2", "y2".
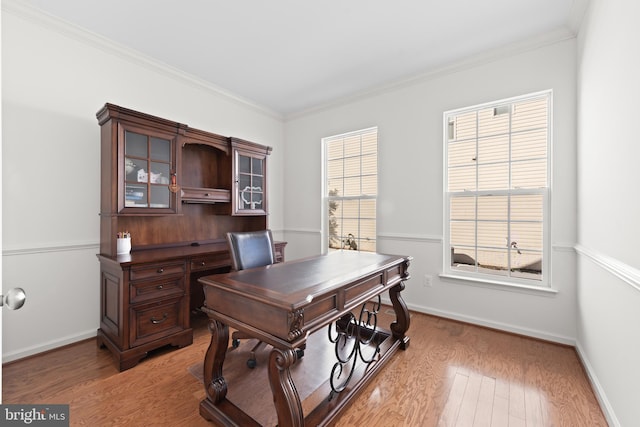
[{"x1": 124, "y1": 129, "x2": 175, "y2": 213}]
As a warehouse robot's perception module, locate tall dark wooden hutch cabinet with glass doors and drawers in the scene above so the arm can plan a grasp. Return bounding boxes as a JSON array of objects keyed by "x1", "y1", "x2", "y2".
[{"x1": 97, "y1": 104, "x2": 286, "y2": 370}]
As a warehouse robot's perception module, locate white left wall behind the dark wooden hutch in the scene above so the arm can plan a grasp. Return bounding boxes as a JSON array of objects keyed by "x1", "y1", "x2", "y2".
[{"x1": 2, "y1": 0, "x2": 284, "y2": 362}]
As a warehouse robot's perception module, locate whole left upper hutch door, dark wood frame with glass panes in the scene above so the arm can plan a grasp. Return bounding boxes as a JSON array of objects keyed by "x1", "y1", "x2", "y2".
[{"x1": 118, "y1": 124, "x2": 177, "y2": 215}]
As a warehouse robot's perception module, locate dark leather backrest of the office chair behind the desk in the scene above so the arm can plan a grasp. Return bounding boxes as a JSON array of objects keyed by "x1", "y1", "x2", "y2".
[{"x1": 227, "y1": 230, "x2": 276, "y2": 270}]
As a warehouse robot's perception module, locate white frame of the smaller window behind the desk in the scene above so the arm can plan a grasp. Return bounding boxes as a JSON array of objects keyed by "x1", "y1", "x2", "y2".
[{"x1": 321, "y1": 126, "x2": 379, "y2": 253}]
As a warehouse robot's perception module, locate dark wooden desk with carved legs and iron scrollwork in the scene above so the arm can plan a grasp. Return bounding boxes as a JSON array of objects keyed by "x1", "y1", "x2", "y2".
[{"x1": 200, "y1": 251, "x2": 412, "y2": 427}]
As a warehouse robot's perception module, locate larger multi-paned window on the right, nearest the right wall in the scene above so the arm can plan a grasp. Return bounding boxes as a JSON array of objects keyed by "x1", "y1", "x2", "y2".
[{"x1": 444, "y1": 91, "x2": 552, "y2": 286}]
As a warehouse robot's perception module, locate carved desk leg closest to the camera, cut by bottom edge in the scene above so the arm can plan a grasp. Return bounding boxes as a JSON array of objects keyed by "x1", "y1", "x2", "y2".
[{"x1": 269, "y1": 347, "x2": 304, "y2": 427}]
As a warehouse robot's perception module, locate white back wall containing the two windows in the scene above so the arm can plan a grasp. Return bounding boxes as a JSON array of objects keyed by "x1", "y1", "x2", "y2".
[{"x1": 284, "y1": 39, "x2": 576, "y2": 344}]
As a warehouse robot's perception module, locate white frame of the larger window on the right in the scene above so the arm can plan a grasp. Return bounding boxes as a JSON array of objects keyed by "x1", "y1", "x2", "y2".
[{"x1": 442, "y1": 89, "x2": 553, "y2": 290}]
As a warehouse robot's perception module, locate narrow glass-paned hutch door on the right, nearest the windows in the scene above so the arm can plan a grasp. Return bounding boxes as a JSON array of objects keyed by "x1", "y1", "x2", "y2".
[{"x1": 232, "y1": 149, "x2": 267, "y2": 215}]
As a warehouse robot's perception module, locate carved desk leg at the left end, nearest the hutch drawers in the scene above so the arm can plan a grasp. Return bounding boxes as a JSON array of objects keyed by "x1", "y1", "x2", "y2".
[{"x1": 200, "y1": 318, "x2": 229, "y2": 420}]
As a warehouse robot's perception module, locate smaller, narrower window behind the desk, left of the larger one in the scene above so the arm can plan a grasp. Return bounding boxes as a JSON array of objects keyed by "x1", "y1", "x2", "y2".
[{"x1": 322, "y1": 128, "x2": 378, "y2": 252}]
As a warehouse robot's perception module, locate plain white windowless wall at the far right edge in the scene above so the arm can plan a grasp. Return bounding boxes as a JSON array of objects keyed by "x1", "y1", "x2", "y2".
[{"x1": 577, "y1": 0, "x2": 640, "y2": 426}]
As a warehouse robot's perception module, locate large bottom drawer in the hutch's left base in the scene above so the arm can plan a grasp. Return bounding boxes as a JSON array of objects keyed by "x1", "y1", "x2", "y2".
[{"x1": 129, "y1": 297, "x2": 184, "y2": 347}]
